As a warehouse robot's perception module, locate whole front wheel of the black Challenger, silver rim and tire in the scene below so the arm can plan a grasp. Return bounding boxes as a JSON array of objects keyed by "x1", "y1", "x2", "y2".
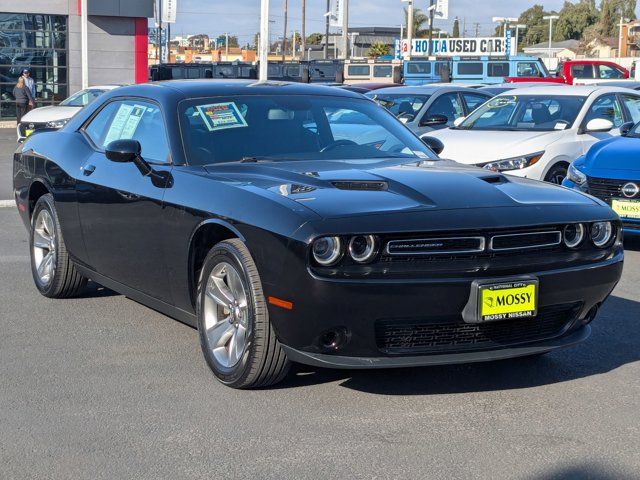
[{"x1": 196, "y1": 239, "x2": 290, "y2": 388}]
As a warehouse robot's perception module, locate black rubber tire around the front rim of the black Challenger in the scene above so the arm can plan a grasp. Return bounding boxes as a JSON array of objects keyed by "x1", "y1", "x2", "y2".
[{"x1": 196, "y1": 239, "x2": 290, "y2": 389}]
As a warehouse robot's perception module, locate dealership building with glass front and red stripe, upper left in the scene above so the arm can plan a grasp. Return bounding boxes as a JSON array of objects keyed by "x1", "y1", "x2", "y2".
[{"x1": 0, "y1": 0, "x2": 154, "y2": 121}]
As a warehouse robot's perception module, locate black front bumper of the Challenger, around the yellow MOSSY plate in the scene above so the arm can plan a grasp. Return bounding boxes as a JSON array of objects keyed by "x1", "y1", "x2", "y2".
[{"x1": 265, "y1": 247, "x2": 623, "y2": 368}]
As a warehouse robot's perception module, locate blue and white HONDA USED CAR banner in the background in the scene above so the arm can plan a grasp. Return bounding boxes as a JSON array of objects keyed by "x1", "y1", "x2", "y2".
[{"x1": 402, "y1": 34, "x2": 516, "y2": 57}]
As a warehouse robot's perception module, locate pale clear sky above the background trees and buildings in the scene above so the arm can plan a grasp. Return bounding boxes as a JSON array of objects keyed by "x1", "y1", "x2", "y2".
[{"x1": 156, "y1": 0, "x2": 636, "y2": 44}]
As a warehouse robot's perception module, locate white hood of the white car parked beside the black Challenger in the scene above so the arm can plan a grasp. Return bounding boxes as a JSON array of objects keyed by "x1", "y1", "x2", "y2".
[{"x1": 426, "y1": 128, "x2": 567, "y2": 164}]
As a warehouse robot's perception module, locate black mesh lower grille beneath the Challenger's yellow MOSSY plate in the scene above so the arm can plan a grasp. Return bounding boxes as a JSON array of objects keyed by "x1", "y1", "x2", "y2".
[{"x1": 375, "y1": 303, "x2": 582, "y2": 355}]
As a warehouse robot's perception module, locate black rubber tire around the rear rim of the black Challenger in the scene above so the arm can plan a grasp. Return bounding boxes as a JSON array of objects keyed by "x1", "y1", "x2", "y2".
[{"x1": 29, "y1": 194, "x2": 87, "y2": 298}]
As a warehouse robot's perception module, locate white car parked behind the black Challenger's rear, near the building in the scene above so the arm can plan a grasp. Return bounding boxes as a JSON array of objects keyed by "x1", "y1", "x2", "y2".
[{"x1": 17, "y1": 85, "x2": 120, "y2": 142}]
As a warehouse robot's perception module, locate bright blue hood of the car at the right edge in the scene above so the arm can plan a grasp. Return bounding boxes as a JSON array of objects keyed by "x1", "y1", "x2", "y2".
[{"x1": 581, "y1": 137, "x2": 640, "y2": 178}]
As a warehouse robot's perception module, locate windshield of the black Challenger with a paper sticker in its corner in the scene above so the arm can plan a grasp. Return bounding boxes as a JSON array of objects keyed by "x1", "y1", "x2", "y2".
[{"x1": 179, "y1": 95, "x2": 436, "y2": 165}]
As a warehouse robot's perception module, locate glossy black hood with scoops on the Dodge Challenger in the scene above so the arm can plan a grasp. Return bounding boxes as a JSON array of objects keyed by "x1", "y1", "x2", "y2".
[{"x1": 205, "y1": 159, "x2": 595, "y2": 218}]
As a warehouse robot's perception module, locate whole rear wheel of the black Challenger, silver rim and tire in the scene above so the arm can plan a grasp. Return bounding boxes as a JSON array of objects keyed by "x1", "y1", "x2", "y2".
[{"x1": 29, "y1": 194, "x2": 87, "y2": 298}]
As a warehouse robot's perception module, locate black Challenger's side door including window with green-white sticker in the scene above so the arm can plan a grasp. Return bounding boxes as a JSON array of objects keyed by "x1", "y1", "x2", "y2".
[{"x1": 76, "y1": 98, "x2": 171, "y2": 300}]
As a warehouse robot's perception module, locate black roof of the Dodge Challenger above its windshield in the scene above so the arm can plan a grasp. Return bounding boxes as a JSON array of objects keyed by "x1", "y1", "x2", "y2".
[{"x1": 117, "y1": 79, "x2": 362, "y2": 98}]
